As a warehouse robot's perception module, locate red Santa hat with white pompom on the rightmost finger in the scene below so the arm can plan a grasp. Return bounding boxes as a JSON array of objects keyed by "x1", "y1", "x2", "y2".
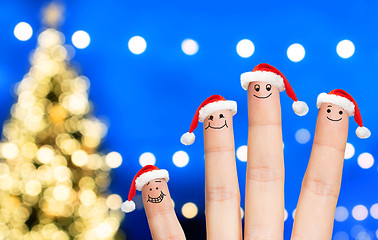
[{"x1": 316, "y1": 89, "x2": 371, "y2": 138}]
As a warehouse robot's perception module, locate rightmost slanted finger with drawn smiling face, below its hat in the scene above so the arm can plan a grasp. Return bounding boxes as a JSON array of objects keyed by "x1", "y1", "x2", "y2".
[{"x1": 292, "y1": 103, "x2": 348, "y2": 240}]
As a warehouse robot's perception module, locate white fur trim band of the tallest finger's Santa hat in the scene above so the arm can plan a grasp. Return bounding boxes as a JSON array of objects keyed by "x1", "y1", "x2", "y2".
[{"x1": 240, "y1": 71, "x2": 285, "y2": 92}]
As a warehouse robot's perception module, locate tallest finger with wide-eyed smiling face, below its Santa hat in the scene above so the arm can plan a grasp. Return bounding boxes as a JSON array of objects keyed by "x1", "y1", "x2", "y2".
[{"x1": 245, "y1": 82, "x2": 284, "y2": 239}]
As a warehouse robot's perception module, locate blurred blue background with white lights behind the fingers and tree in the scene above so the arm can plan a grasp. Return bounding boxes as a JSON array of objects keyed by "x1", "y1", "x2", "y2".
[{"x1": 0, "y1": 0, "x2": 378, "y2": 240}]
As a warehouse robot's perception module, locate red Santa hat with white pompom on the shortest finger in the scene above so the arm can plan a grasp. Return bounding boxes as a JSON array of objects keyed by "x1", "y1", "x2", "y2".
[{"x1": 121, "y1": 165, "x2": 169, "y2": 213}]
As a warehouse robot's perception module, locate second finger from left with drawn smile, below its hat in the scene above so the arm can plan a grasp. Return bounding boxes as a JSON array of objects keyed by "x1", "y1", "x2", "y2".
[{"x1": 203, "y1": 110, "x2": 242, "y2": 240}]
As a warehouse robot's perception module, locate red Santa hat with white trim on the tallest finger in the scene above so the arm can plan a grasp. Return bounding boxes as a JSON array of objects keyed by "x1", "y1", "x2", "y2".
[{"x1": 240, "y1": 63, "x2": 308, "y2": 116}]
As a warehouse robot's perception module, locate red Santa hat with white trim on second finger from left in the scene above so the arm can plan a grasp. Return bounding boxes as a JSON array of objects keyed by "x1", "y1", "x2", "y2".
[{"x1": 180, "y1": 95, "x2": 237, "y2": 145}]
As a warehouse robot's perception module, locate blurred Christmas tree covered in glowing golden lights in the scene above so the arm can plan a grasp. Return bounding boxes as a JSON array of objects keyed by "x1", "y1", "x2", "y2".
[{"x1": 0, "y1": 4, "x2": 124, "y2": 240}]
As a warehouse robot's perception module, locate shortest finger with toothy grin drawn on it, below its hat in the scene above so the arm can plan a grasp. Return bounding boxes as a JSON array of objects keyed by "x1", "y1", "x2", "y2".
[{"x1": 142, "y1": 179, "x2": 185, "y2": 240}]
